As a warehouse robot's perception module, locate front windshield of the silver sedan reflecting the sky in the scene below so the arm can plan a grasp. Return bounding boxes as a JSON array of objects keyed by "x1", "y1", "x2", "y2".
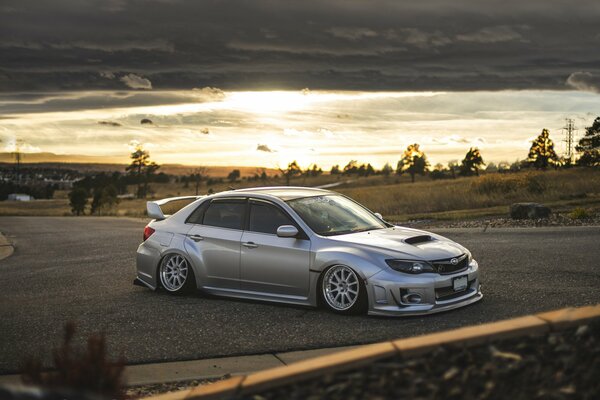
[{"x1": 287, "y1": 195, "x2": 387, "y2": 236}]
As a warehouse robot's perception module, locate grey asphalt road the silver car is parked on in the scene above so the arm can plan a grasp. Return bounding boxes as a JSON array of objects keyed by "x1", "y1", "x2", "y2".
[{"x1": 0, "y1": 217, "x2": 600, "y2": 373}]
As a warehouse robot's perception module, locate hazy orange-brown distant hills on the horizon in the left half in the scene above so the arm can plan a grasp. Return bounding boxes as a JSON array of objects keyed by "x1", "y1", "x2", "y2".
[{"x1": 0, "y1": 153, "x2": 279, "y2": 177}]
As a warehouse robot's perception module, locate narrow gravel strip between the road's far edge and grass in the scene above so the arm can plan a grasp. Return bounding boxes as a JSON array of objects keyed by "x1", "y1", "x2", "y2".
[{"x1": 397, "y1": 214, "x2": 600, "y2": 229}]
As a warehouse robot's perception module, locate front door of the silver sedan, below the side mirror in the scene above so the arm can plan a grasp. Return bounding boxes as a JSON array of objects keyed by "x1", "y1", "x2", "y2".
[{"x1": 240, "y1": 199, "x2": 310, "y2": 297}]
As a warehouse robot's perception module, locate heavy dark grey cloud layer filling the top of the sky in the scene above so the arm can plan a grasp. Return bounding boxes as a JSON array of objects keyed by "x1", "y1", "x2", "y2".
[{"x1": 0, "y1": 0, "x2": 600, "y2": 91}]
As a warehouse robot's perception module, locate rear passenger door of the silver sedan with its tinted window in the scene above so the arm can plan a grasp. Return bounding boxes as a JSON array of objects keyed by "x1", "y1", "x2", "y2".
[{"x1": 185, "y1": 198, "x2": 247, "y2": 289}]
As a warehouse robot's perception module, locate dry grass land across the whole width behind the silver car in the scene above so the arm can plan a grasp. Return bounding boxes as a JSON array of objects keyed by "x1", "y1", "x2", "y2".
[{"x1": 0, "y1": 168, "x2": 600, "y2": 221}]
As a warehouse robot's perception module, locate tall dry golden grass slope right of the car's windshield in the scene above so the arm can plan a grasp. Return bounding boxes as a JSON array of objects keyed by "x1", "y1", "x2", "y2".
[{"x1": 336, "y1": 169, "x2": 600, "y2": 220}]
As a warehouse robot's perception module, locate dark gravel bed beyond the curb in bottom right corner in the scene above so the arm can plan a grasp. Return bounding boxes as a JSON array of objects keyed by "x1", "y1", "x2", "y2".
[{"x1": 244, "y1": 320, "x2": 600, "y2": 400}]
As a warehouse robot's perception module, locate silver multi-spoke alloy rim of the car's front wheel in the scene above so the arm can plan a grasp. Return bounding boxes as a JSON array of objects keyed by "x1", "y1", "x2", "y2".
[{"x1": 323, "y1": 265, "x2": 360, "y2": 311}]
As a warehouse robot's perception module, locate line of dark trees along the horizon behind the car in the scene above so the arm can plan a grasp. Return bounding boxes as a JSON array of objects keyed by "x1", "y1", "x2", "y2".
[{"x1": 69, "y1": 117, "x2": 600, "y2": 215}]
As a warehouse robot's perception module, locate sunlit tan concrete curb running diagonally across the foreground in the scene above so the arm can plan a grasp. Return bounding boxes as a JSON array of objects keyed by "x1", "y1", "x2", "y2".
[{"x1": 147, "y1": 305, "x2": 600, "y2": 400}]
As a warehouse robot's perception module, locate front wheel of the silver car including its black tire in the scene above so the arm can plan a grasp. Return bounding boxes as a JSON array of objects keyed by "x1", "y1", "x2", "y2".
[{"x1": 319, "y1": 265, "x2": 368, "y2": 314}]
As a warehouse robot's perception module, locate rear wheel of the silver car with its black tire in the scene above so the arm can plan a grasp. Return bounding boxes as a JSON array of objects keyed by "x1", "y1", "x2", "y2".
[{"x1": 158, "y1": 254, "x2": 196, "y2": 294}]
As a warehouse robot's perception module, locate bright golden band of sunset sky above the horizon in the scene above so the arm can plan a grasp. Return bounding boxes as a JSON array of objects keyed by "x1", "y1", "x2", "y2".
[{"x1": 0, "y1": 88, "x2": 599, "y2": 168}]
